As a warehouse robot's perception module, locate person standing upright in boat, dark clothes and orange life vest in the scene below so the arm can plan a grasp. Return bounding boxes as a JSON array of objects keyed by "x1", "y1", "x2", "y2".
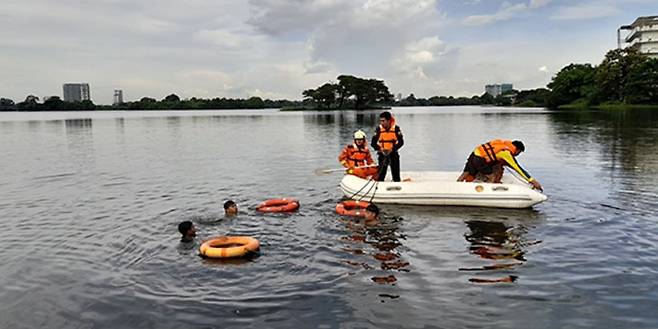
[{"x1": 371, "y1": 111, "x2": 404, "y2": 182}]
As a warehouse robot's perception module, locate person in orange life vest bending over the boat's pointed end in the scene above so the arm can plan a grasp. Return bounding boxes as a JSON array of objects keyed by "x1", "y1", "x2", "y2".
[{"x1": 457, "y1": 139, "x2": 543, "y2": 191}]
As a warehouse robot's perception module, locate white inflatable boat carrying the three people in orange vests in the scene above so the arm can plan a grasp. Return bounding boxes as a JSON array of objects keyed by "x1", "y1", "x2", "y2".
[{"x1": 340, "y1": 171, "x2": 547, "y2": 208}]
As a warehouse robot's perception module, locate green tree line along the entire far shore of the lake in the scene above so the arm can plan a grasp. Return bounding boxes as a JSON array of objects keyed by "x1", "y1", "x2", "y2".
[{"x1": 0, "y1": 47, "x2": 658, "y2": 111}]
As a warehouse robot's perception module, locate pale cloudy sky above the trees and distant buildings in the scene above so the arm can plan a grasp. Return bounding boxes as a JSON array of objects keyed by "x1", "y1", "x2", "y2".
[{"x1": 0, "y1": 0, "x2": 658, "y2": 104}]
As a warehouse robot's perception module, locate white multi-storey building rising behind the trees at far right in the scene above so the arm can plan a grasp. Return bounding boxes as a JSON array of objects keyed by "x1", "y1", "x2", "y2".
[{"x1": 617, "y1": 16, "x2": 658, "y2": 58}]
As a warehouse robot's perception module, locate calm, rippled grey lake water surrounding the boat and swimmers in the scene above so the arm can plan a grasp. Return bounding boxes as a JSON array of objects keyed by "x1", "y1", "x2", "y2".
[{"x1": 0, "y1": 107, "x2": 658, "y2": 328}]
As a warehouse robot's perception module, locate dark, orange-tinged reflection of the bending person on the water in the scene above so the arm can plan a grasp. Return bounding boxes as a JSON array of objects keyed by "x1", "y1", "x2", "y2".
[{"x1": 459, "y1": 220, "x2": 541, "y2": 283}]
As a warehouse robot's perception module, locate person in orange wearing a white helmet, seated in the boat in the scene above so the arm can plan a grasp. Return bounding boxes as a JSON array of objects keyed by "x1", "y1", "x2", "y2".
[{"x1": 338, "y1": 130, "x2": 377, "y2": 179}]
